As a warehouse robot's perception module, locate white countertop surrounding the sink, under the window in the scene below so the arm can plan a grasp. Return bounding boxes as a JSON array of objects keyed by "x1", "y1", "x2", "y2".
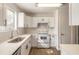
[{"x1": 0, "y1": 34, "x2": 31, "y2": 55}]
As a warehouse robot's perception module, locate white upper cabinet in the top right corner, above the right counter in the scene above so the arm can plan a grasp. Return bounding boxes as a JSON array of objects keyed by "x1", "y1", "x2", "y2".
[{"x1": 69, "y1": 3, "x2": 79, "y2": 25}]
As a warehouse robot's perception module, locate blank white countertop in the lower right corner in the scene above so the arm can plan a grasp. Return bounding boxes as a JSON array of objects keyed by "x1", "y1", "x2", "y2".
[{"x1": 60, "y1": 44, "x2": 79, "y2": 55}]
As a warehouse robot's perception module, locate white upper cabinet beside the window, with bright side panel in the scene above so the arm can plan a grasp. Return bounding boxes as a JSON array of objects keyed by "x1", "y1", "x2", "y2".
[{"x1": 18, "y1": 12, "x2": 32, "y2": 28}]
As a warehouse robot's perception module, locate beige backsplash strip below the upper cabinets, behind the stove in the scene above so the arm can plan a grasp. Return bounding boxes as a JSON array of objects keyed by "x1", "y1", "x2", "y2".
[{"x1": 24, "y1": 28, "x2": 54, "y2": 34}]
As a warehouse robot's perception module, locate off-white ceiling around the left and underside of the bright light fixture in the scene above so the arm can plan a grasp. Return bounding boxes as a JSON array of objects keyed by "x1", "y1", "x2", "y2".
[{"x1": 16, "y1": 3, "x2": 57, "y2": 13}]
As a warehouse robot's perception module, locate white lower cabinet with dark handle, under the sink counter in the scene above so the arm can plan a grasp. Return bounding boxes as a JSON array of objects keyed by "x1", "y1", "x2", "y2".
[{"x1": 21, "y1": 37, "x2": 31, "y2": 55}]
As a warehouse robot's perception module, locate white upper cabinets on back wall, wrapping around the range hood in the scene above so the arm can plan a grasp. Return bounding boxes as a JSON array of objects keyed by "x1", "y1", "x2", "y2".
[{"x1": 32, "y1": 17, "x2": 55, "y2": 28}]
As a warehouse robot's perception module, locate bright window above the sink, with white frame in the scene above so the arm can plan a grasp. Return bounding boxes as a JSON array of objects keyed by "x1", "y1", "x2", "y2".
[{"x1": 6, "y1": 8, "x2": 17, "y2": 30}]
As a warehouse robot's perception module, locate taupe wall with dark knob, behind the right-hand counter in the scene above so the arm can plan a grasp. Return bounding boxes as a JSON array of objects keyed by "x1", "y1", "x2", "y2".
[{"x1": 59, "y1": 4, "x2": 75, "y2": 44}]
